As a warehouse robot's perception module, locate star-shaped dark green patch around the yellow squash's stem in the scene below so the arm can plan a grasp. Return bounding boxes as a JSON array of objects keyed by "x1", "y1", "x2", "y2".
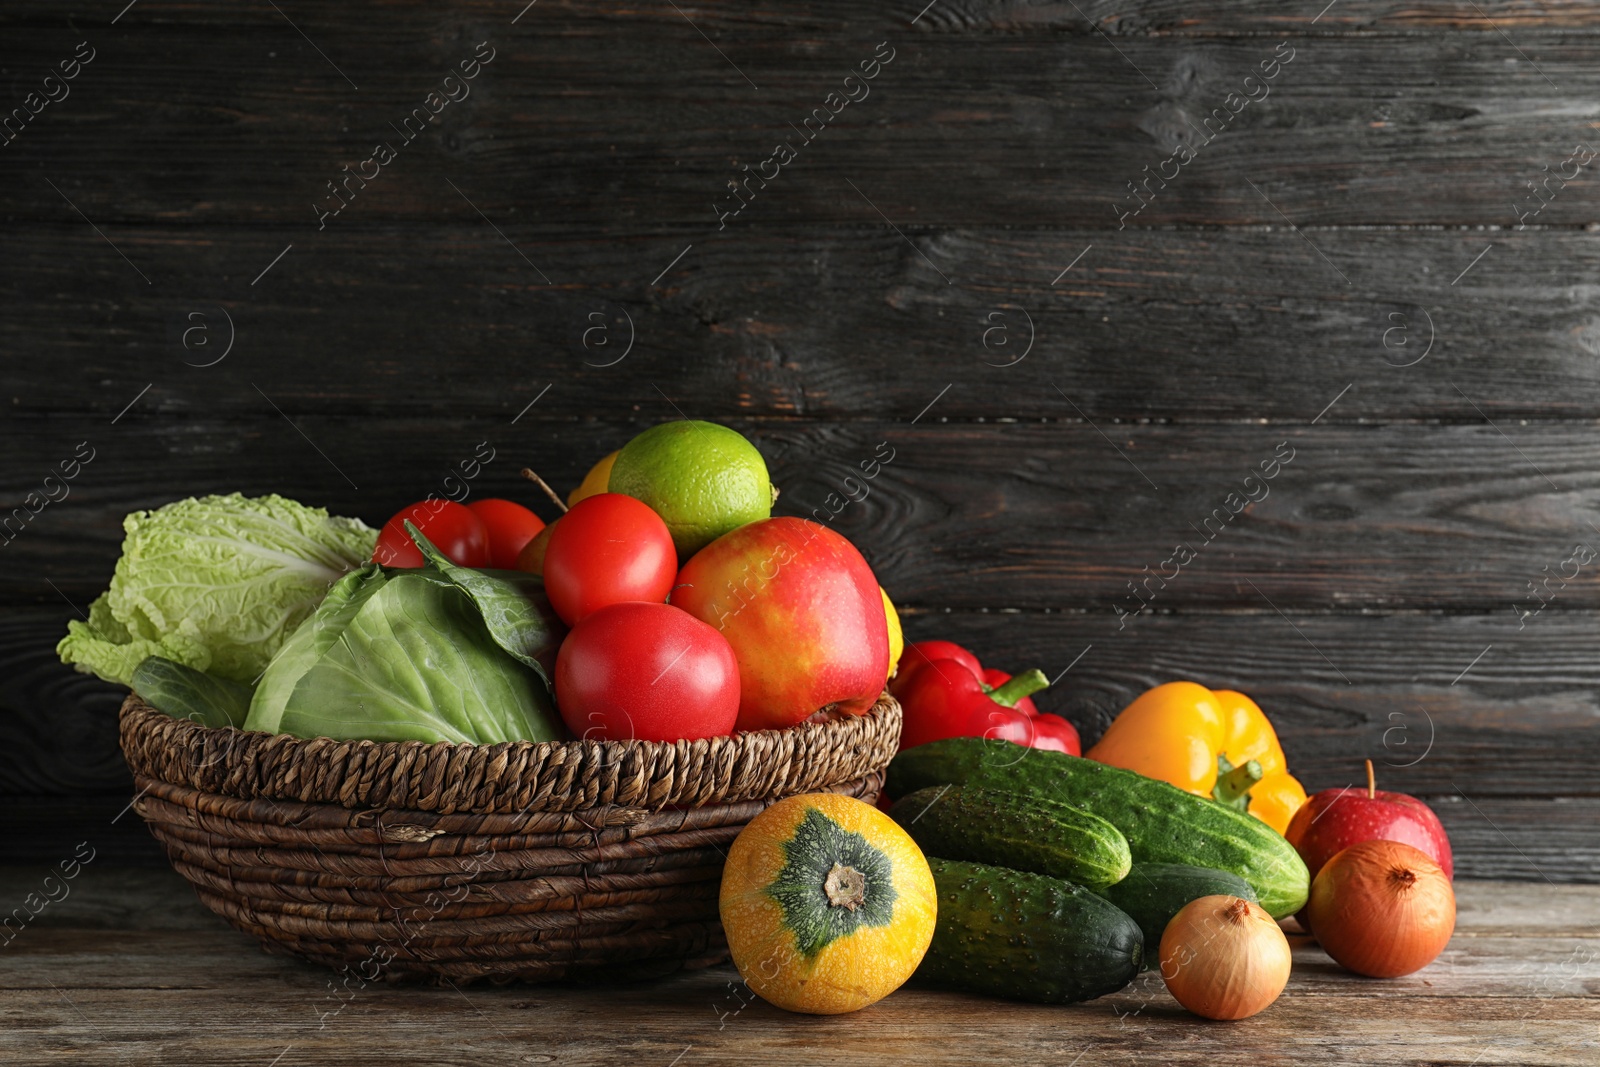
[{"x1": 766, "y1": 809, "x2": 898, "y2": 958}]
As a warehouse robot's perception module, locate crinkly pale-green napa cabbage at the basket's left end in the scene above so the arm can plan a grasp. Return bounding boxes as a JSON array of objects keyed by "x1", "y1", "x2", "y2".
[{"x1": 56, "y1": 493, "x2": 378, "y2": 685}]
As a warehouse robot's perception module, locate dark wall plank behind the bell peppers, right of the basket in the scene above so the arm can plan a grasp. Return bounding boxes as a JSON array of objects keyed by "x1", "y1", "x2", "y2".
[{"x1": 906, "y1": 613, "x2": 1600, "y2": 799}]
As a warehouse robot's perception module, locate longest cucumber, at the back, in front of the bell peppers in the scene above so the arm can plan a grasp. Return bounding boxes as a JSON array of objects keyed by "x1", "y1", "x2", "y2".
[{"x1": 888, "y1": 737, "x2": 1310, "y2": 918}]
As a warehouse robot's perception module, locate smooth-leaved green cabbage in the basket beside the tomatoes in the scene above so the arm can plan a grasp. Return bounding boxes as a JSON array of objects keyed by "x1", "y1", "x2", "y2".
[{"x1": 233, "y1": 528, "x2": 565, "y2": 744}]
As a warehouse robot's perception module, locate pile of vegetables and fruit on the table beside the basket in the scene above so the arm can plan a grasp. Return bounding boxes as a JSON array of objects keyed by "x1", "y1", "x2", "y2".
[{"x1": 722, "y1": 697, "x2": 1456, "y2": 1019}]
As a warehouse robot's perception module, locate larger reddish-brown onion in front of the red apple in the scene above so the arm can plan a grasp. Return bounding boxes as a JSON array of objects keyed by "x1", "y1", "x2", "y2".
[{"x1": 1306, "y1": 841, "x2": 1456, "y2": 977}]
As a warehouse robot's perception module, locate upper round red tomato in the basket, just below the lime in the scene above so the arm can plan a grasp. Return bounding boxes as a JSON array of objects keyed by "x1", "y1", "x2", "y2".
[{"x1": 544, "y1": 493, "x2": 678, "y2": 625}]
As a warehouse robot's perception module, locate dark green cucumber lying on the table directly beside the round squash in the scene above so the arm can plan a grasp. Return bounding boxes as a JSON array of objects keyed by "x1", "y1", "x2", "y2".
[{"x1": 917, "y1": 856, "x2": 1144, "y2": 1005}]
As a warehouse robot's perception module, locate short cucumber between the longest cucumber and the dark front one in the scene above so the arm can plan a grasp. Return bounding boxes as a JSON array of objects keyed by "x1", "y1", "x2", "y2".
[{"x1": 890, "y1": 785, "x2": 1133, "y2": 889}]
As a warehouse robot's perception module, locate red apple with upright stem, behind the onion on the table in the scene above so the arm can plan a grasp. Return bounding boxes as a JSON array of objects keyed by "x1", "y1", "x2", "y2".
[{"x1": 1283, "y1": 760, "x2": 1454, "y2": 878}]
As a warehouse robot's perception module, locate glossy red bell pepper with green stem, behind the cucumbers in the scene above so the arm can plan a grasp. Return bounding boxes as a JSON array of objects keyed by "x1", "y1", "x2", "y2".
[{"x1": 890, "y1": 641, "x2": 1082, "y2": 755}]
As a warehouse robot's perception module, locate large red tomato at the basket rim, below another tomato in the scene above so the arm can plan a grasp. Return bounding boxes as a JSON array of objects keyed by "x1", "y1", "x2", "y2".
[{"x1": 546, "y1": 601, "x2": 739, "y2": 741}]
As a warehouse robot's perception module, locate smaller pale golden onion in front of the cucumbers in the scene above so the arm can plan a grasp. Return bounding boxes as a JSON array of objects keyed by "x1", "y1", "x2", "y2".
[{"x1": 1162, "y1": 896, "x2": 1290, "y2": 1019}]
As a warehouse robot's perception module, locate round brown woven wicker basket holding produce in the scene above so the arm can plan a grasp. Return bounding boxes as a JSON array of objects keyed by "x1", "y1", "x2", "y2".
[{"x1": 122, "y1": 694, "x2": 901, "y2": 982}]
